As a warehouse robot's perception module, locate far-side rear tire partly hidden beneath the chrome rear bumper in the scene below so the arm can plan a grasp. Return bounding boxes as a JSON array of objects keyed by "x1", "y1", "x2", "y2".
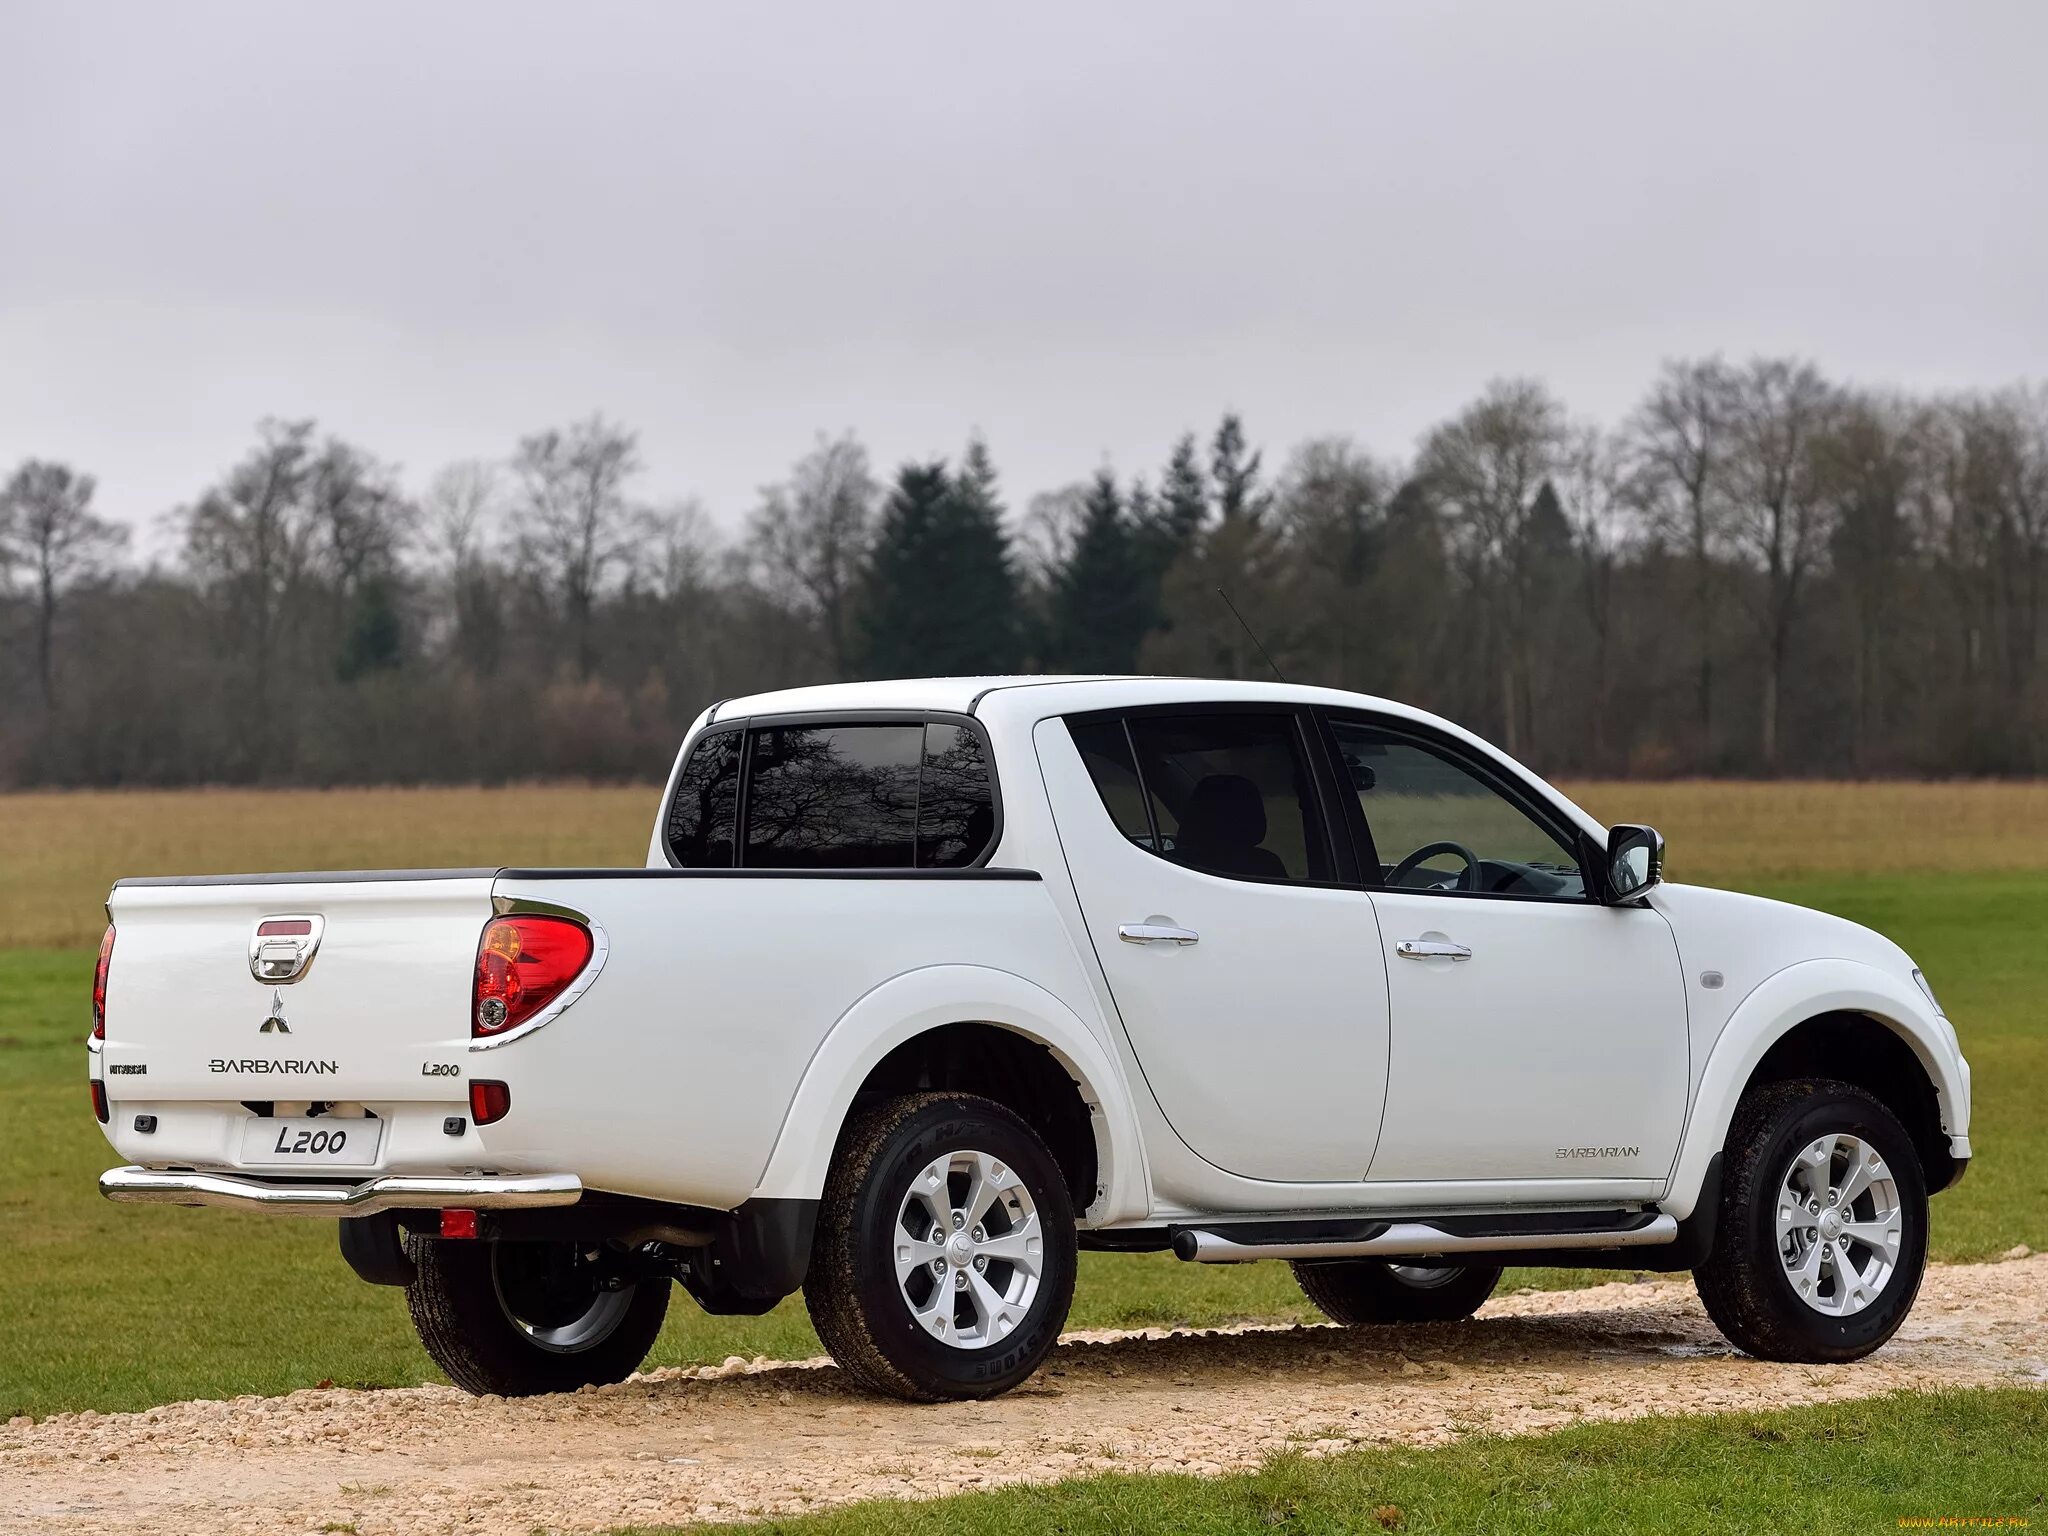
[{"x1": 406, "y1": 1237, "x2": 670, "y2": 1397}]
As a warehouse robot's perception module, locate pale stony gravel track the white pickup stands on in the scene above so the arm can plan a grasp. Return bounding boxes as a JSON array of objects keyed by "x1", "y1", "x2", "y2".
[{"x1": 0, "y1": 1255, "x2": 2048, "y2": 1536}]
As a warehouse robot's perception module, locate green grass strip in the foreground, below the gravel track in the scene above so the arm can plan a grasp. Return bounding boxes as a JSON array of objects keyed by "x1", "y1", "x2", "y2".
[{"x1": 621, "y1": 1389, "x2": 2048, "y2": 1536}]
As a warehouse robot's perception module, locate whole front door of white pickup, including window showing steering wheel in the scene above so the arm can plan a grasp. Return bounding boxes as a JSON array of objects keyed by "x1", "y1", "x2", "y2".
[{"x1": 1331, "y1": 719, "x2": 1690, "y2": 1182}]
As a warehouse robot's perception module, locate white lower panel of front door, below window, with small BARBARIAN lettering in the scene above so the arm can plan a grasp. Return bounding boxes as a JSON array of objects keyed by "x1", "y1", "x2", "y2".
[{"x1": 1370, "y1": 891, "x2": 1688, "y2": 1182}]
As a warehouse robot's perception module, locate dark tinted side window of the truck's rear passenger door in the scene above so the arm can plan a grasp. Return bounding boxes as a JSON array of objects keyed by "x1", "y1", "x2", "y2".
[{"x1": 1069, "y1": 713, "x2": 1329, "y2": 881}]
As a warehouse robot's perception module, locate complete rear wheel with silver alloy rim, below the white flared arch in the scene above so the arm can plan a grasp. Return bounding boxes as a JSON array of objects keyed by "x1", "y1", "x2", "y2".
[{"x1": 803, "y1": 1094, "x2": 1075, "y2": 1403}]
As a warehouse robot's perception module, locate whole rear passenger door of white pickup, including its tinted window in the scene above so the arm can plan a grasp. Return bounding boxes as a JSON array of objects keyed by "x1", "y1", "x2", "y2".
[{"x1": 1038, "y1": 707, "x2": 1386, "y2": 1182}]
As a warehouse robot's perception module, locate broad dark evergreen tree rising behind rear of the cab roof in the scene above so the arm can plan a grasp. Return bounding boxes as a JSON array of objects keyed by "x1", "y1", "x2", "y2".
[{"x1": 862, "y1": 450, "x2": 1020, "y2": 678}]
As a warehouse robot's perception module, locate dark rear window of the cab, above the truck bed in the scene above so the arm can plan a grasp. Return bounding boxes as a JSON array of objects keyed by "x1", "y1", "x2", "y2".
[{"x1": 668, "y1": 719, "x2": 995, "y2": 870}]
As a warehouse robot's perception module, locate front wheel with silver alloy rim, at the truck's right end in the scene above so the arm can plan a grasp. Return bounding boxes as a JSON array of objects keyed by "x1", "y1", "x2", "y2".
[{"x1": 1694, "y1": 1079, "x2": 1927, "y2": 1362}]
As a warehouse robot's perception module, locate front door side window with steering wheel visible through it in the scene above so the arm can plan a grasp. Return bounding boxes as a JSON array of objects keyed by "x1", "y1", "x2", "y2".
[{"x1": 1331, "y1": 721, "x2": 1585, "y2": 899}]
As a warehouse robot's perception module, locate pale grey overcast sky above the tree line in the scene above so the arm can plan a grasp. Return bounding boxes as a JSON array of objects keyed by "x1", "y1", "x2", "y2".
[{"x1": 0, "y1": 0, "x2": 2048, "y2": 548}]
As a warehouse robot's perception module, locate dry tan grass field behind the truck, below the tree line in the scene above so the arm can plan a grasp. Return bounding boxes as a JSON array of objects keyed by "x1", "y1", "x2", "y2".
[{"x1": 12, "y1": 780, "x2": 2048, "y2": 948}]
